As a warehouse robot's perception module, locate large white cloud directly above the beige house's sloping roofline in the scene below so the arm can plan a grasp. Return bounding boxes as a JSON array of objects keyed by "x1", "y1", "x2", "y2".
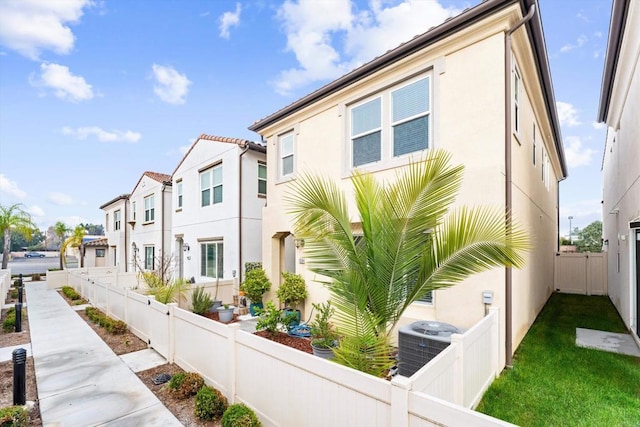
[{"x1": 274, "y1": 0, "x2": 459, "y2": 94}]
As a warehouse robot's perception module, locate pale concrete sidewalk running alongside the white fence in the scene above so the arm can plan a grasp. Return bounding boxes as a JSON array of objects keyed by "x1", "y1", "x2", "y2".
[{"x1": 25, "y1": 282, "x2": 182, "y2": 427}]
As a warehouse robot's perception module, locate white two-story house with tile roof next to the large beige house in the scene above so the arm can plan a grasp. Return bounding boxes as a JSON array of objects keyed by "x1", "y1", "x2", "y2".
[{"x1": 171, "y1": 134, "x2": 267, "y2": 283}]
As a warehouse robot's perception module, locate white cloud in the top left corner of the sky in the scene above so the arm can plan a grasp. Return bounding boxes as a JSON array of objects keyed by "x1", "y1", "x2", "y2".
[{"x1": 0, "y1": 0, "x2": 92, "y2": 60}]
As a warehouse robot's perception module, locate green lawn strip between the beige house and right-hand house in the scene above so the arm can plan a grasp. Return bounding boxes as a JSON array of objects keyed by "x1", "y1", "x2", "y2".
[{"x1": 477, "y1": 294, "x2": 640, "y2": 427}]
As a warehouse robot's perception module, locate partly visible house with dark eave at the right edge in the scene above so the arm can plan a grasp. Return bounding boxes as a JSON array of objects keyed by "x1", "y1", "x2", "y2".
[{"x1": 598, "y1": 0, "x2": 640, "y2": 343}]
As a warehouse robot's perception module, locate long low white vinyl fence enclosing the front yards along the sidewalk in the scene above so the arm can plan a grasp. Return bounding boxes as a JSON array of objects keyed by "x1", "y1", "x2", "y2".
[{"x1": 63, "y1": 272, "x2": 511, "y2": 427}]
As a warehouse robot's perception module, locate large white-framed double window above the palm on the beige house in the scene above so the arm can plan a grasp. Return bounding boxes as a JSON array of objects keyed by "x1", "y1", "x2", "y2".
[{"x1": 349, "y1": 76, "x2": 431, "y2": 167}]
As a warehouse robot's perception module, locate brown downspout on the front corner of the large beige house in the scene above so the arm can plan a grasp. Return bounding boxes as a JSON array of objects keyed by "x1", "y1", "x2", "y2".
[{"x1": 504, "y1": 4, "x2": 536, "y2": 368}]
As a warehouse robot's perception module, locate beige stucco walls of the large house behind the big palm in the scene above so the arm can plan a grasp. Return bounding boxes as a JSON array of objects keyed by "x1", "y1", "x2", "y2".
[{"x1": 262, "y1": 3, "x2": 560, "y2": 364}]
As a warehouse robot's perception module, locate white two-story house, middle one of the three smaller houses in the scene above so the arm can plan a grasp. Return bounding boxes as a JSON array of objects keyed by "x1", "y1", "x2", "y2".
[{"x1": 129, "y1": 171, "x2": 175, "y2": 271}]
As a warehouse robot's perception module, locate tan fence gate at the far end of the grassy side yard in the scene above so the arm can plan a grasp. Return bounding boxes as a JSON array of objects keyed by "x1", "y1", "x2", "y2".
[{"x1": 554, "y1": 252, "x2": 607, "y2": 295}]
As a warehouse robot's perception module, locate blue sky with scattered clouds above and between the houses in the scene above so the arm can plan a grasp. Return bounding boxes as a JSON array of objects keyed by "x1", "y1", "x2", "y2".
[{"x1": 0, "y1": 0, "x2": 611, "y2": 235}]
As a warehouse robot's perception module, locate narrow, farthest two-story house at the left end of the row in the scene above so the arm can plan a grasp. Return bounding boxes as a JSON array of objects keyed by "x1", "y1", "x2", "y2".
[{"x1": 100, "y1": 194, "x2": 129, "y2": 272}]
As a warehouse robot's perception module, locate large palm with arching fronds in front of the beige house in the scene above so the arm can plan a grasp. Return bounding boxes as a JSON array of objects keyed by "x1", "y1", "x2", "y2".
[{"x1": 287, "y1": 150, "x2": 529, "y2": 375}]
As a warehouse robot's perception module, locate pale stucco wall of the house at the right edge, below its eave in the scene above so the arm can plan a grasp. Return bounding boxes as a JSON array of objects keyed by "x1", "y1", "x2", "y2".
[{"x1": 602, "y1": 2, "x2": 640, "y2": 338}]
